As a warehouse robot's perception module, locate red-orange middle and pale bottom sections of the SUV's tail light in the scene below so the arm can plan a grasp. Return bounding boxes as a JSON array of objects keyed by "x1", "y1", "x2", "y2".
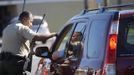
[{"x1": 102, "y1": 34, "x2": 117, "y2": 75}]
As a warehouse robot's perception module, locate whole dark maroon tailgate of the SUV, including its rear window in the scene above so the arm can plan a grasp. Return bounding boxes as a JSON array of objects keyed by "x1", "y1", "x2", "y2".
[{"x1": 116, "y1": 14, "x2": 134, "y2": 75}]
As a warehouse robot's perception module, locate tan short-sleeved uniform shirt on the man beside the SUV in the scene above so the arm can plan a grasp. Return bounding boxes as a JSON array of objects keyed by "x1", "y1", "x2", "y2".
[{"x1": 2, "y1": 23, "x2": 37, "y2": 56}]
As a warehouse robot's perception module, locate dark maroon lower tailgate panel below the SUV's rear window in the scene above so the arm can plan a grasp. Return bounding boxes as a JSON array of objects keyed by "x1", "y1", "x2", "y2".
[{"x1": 117, "y1": 56, "x2": 134, "y2": 75}]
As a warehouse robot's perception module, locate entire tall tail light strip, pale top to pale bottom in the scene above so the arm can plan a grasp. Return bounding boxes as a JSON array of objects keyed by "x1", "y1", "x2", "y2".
[{"x1": 102, "y1": 20, "x2": 119, "y2": 75}]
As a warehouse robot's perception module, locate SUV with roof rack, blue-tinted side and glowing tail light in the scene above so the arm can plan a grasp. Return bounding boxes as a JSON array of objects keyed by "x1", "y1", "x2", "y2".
[{"x1": 36, "y1": 5, "x2": 134, "y2": 75}]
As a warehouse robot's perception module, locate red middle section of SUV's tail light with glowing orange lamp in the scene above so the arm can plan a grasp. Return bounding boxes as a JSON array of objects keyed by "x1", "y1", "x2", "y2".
[{"x1": 107, "y1": 34, "x2": 117, "y2": 64}]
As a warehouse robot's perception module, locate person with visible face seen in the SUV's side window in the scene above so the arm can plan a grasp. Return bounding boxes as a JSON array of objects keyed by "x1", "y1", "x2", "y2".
[{"x1": 64, "y1": 32, "x2": 83, "y2": 63}]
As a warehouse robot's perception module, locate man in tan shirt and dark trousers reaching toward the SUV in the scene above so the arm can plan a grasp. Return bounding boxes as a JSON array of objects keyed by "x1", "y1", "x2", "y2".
[{"x1": 0, "y1": 11, "x2": 56, "y2": 75}]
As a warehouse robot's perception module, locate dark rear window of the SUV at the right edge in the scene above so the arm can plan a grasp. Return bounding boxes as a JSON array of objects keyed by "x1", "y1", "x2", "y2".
[{"x1": 117, "y1": 16, "x2": 134, "y2": 56}]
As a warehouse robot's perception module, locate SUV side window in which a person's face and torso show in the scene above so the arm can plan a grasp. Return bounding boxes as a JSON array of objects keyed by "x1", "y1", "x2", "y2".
[{"x1": 67, "y1": 22, "x2": 86, "y2": 59}]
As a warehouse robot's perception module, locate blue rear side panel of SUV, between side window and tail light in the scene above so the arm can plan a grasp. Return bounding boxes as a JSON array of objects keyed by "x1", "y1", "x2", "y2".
[{"x1": 79, "y1": 12, "x2": 114, "y2": 71}]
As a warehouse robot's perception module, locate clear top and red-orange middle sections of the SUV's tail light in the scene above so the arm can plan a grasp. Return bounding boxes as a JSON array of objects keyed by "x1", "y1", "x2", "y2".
[{"x1": 106, "y1": 21, "x2": 119, "y2": 64}]
